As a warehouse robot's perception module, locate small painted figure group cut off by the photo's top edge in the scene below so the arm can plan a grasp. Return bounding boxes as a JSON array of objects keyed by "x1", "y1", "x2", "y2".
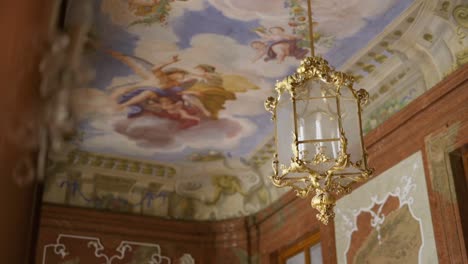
[{"x1": 127, "y1": 0, "x2": 188, "y2": 26}]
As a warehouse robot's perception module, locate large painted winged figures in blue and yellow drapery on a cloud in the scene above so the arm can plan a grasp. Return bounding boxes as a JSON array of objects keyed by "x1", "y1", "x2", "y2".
[{"x1": 108, "y1": 51, "x2": 258, "y2": 129}]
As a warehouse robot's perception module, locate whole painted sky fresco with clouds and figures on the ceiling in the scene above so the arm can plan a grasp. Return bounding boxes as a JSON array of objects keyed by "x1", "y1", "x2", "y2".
[{"x1": 74, "y1": 0, "x2": 412, "y2": 162}]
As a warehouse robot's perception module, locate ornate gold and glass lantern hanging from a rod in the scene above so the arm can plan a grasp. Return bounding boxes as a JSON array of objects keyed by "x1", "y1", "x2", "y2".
[{"x1": 265, "y1": 0, "x2": 373, "y2": 224}]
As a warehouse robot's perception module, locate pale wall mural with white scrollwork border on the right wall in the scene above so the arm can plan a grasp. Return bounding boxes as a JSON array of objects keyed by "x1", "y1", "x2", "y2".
[{"x1": 335, "y1": 152, "x2": 438, "y2": 263}]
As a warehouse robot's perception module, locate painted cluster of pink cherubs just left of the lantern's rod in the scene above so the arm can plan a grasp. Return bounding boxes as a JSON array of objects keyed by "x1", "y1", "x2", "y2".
[{"x1": 250, "y1": 27, "x2": 309, "y2": 63}]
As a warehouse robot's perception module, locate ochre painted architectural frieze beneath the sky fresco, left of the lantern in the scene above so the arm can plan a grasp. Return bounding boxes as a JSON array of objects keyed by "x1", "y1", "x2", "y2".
[{"x1": 43, "y1": 145, "x2": 285, "y2": 220}]
